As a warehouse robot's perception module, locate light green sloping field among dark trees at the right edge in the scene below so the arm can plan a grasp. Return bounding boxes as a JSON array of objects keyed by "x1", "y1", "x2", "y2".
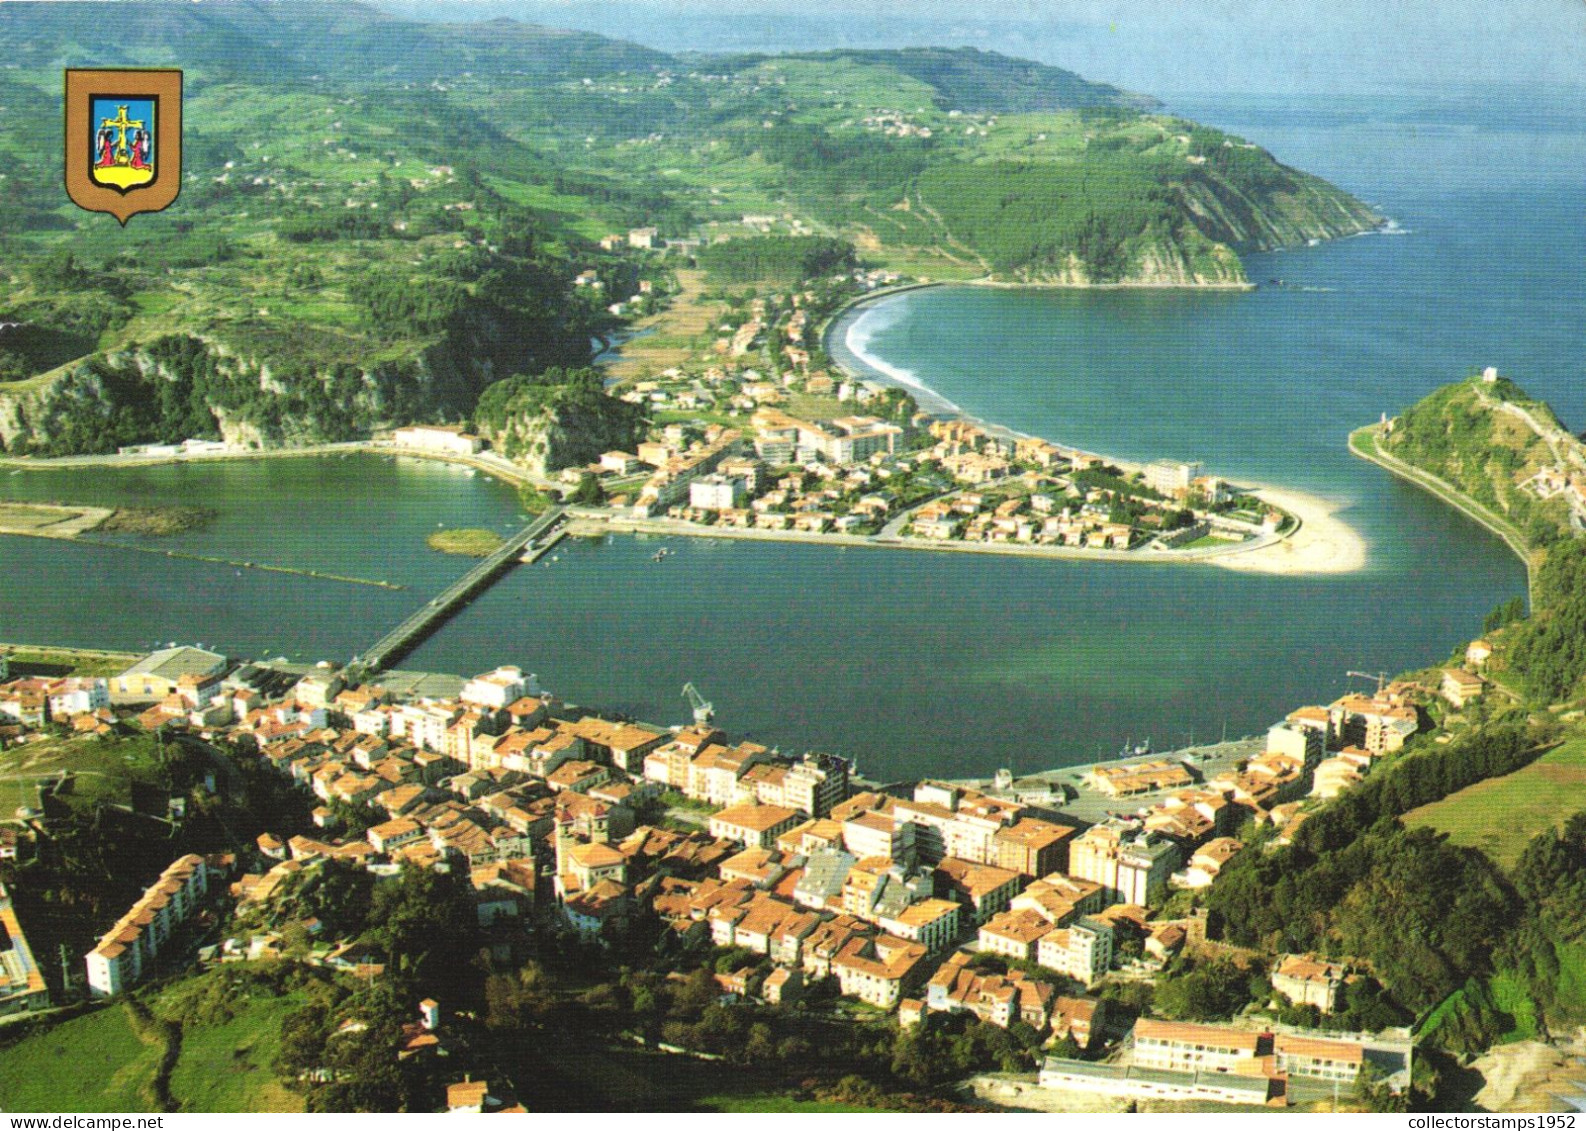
[{"x1": 1404, "y1": 736, "x2": 1586, "y2": 868}]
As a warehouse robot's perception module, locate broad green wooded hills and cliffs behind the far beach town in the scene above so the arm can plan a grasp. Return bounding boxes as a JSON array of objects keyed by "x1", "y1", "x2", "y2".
[{"x1": 0, "y1": 0, "x2": 1377, "y2": 454}]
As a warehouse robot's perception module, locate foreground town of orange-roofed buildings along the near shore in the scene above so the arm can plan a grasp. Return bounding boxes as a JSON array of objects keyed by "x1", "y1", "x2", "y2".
[{"x1": 0, "y1": 641, "x2": 1459, "y2": 1102}]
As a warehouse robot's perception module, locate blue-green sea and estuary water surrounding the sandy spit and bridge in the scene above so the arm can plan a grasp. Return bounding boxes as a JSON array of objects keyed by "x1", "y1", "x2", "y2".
[{"x1": 0, "y1": 90, "x2": 1586, "y2": 779}]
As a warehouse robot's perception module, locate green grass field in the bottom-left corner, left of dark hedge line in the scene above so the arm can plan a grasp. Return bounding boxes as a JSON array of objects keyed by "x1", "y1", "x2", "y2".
[{"x1": 0, "y1": 1006, "x2": 163, "y2": 1112}]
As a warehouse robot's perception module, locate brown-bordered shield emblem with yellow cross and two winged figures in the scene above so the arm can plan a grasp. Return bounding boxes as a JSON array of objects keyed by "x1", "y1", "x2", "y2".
[{"x1": 67, "y1": 68, "x2": 182, "y2": 224}]
